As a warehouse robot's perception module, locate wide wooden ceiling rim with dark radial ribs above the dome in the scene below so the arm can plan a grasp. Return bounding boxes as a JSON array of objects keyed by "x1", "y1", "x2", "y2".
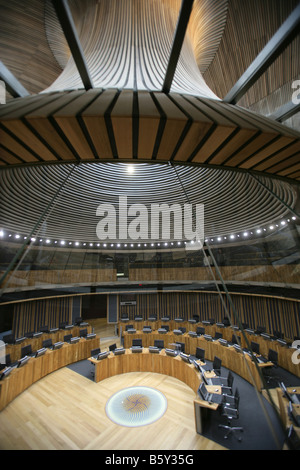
[{"x1": 0, "y1": 89, "x2": 300, "y2": 182}]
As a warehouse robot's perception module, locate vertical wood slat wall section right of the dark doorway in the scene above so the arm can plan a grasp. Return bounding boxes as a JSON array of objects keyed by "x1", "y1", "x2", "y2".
[{"x1": 120, "y1": 292, "x2": 300, "y2": 339}]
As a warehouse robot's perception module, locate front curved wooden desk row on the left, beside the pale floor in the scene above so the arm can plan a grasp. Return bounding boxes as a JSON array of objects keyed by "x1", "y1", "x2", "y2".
[{"x1": 0, "y1": 337, "x2": 100, "y2": 410}]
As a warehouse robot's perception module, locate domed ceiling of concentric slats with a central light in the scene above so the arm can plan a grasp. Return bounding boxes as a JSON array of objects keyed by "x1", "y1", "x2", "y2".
[{"x1": 0, "y1": 161, "x2": 297, "y2": 242}]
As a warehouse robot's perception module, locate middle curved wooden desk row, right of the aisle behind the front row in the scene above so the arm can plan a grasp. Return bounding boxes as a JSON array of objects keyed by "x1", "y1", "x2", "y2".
[{"x1": 124, "y1": 331, "x2": 272, "y2": 391}]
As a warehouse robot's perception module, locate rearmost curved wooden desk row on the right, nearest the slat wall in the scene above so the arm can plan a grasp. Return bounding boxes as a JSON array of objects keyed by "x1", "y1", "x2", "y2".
[{"x1": 120, "y1": 320, "x2": 300, "y2": 377}]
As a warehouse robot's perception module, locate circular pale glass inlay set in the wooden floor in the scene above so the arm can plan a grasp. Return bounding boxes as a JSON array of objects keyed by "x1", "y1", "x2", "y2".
[{"x1": 105, "y1": 387, "x2": 167, "y2": 427}]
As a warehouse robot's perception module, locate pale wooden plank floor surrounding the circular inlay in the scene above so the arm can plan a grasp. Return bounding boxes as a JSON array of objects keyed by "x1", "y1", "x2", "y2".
[{"x1": 0, "y1": 321, "x2": 225, "y2": 450}]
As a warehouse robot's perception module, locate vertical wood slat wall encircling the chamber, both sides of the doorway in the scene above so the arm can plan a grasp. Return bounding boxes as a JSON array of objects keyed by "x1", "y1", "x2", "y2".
[{"x1": 8, "y1": 292, "x2": 300, "y2": 339}]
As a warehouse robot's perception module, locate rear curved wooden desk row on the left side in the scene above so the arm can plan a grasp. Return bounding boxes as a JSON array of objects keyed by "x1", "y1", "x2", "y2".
[{"x1": 5, "y1": 325, "x2": 92, "y2": 362}]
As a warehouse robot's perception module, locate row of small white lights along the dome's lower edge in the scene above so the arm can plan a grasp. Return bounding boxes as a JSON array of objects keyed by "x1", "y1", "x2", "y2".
[{"x1": 0, "y1": 217, "x2": 296, "y2": 248}]
